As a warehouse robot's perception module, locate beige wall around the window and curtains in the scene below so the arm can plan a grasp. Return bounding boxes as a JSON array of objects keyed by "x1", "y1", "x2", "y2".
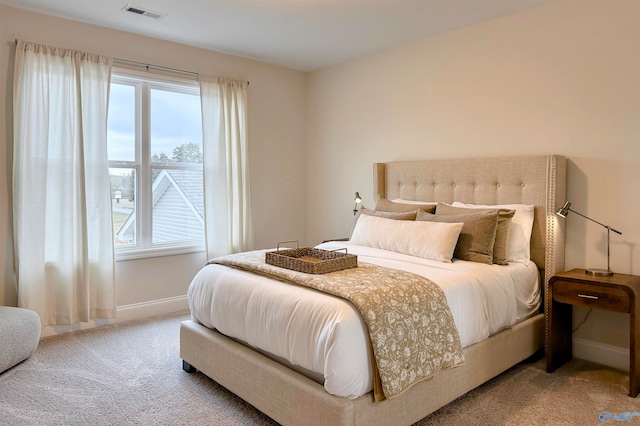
[{"x1": 0, "y1": 6, "x2": 307, "y2": 314}]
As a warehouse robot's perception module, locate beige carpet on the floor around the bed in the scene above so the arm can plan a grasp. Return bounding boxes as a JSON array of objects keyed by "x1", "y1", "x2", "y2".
[{"x1": 0, "y1": 313, "x2": 640, "y2": 426}]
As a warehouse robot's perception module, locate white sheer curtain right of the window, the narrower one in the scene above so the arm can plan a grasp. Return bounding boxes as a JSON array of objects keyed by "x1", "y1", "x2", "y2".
[{"x1": 200, "y1": 76, "x2": 253, "y2": 258}]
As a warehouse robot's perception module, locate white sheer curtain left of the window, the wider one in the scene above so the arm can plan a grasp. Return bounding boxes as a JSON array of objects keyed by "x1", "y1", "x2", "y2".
[{"x1": 13, "y1": 41, "x2": 115, "y2": 325}]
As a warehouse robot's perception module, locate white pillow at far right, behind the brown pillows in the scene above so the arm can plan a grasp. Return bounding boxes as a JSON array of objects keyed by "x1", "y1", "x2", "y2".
[{"x1": 451, "y1": 201, "x2": 535, "y2": 265}]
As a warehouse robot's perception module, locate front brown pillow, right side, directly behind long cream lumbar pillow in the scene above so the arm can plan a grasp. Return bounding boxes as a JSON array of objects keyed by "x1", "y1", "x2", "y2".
[{"x1": 416, "y1": 210, "x2": 498, "y2": 265}]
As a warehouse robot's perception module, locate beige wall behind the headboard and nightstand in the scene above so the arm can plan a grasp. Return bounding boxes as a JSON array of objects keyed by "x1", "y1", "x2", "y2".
[{"x1": 307, "y1": 0, "x2": 640, "y2": 366}]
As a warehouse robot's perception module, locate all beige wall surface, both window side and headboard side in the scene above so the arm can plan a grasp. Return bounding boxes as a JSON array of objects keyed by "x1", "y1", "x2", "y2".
[{"x1": 0, "y1": 0, "x2": 640, "y2": 366}]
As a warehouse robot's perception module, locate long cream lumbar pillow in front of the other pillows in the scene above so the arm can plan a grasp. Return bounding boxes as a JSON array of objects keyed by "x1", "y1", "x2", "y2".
[{"x1": 349, "y1": 215, "x2": 463, "y2": 263}]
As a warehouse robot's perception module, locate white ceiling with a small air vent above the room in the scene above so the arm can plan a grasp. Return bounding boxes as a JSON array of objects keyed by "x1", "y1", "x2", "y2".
[{"x1": 0, "y1": 0, "x2": 550, "y2": 71}]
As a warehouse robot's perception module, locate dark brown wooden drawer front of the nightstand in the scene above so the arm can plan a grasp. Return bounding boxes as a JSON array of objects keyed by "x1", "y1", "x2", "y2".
[{"x1": 553, "y1": 280, "x2": 631, "y2": 312}]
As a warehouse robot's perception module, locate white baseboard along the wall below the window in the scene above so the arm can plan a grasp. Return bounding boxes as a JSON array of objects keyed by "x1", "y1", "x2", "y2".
[{"x1": 40, "y1": 295, "x2": 189, "y2": 338}]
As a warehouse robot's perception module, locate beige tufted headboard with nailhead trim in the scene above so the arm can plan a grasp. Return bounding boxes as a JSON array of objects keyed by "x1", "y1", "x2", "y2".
[{"x1": 373, "y1": 155, "x2": 567, "y2": 284}]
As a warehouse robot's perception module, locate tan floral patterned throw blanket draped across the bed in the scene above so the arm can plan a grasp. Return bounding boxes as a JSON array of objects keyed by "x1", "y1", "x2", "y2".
[{"x1": 208, "y1": 250, "x2": 464, "y2": 401}]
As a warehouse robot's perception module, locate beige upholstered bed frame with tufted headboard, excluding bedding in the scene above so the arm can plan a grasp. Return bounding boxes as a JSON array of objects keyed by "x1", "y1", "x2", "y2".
[{"x1": 180, "y1": 155, "x2": 566, "y2": 425}]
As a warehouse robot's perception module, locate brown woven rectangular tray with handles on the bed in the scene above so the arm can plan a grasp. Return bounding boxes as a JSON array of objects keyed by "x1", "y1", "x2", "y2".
[{"x1": 265, "y1": 241, "x2": 358, "y2": 274}]
